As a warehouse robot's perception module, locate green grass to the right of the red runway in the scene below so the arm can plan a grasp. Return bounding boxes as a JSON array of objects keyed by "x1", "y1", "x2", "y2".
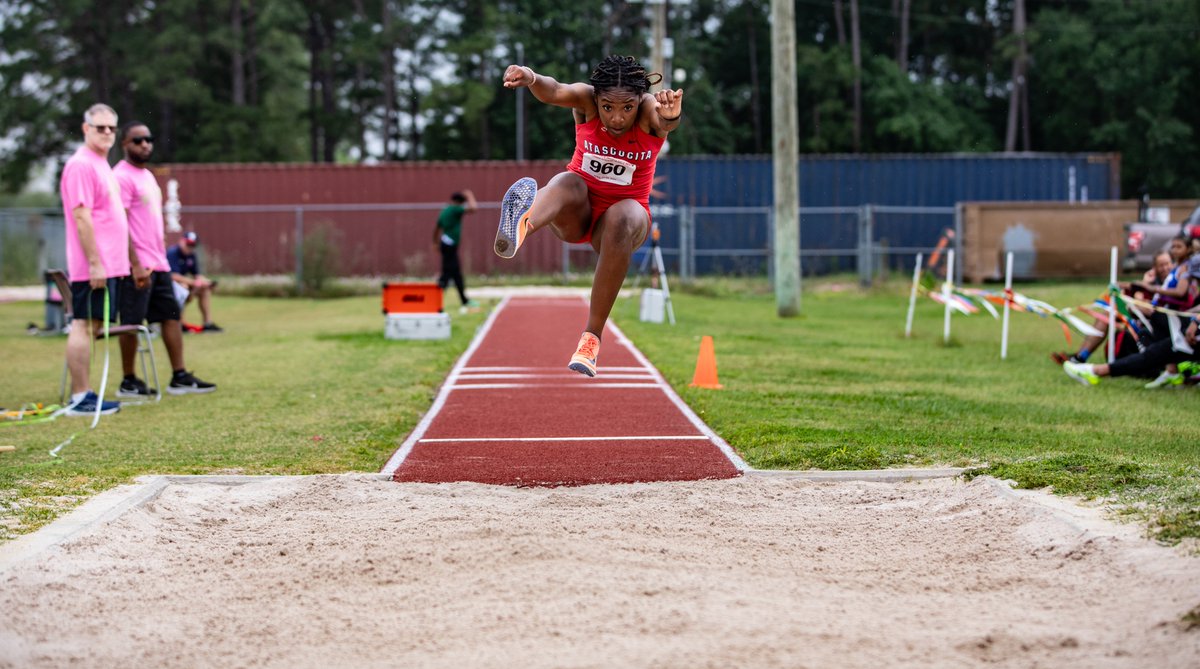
[{"x1": 614, "y1": 281, "x2": 1200, "y2": 542}]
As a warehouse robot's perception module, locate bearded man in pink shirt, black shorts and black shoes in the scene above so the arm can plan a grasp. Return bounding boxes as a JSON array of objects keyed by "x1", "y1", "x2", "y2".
[{"x1": 113, "y1": 121, "x2": 217, "y2": 397}]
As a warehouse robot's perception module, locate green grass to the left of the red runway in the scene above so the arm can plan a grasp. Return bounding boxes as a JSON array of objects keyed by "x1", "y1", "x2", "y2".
[{"x1": 0, "y1": 296, "x2": 486, "y2": 538}]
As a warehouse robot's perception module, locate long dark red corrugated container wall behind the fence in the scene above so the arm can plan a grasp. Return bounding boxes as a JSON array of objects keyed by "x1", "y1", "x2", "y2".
[{"x1": 155, "y1": 159, "x2": 566, "y2": 277}]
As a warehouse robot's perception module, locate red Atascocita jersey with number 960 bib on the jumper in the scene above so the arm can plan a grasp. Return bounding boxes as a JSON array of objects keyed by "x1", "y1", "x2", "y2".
[{"x1": 566, "y1": 116, "x2": 664, "y2": 225}]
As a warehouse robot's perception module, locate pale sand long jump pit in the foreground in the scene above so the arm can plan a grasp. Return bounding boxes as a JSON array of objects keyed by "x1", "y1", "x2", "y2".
[{"x1": 0, "y1": 475, "x2": 1200, "y2": 668}]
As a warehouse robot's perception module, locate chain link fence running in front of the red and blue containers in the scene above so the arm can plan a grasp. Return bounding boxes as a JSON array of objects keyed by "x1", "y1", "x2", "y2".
[{"x1": 0, "y1": 203, "x2": 962, "y2": 285}]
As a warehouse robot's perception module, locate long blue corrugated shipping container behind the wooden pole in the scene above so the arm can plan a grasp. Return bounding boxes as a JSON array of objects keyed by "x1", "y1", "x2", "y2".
[{"x1": 652, "y1": 153, "x2": 1121, "y2": 273}]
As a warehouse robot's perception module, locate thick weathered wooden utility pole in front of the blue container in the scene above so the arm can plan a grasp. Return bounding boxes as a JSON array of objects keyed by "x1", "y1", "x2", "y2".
[{"x1": 770, "y1": 0, "x2": 800, "y2": 318}]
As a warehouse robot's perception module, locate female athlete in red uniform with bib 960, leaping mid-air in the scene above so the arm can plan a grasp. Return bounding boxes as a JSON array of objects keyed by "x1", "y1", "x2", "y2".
[{"x1": 496, "y1": 55, "x2": 683, "y2": 376}]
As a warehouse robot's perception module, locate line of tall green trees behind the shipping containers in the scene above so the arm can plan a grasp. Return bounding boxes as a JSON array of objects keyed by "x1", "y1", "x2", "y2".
[{"x1": 0, "y1": 0, "x2": 1200, "y2": 198}]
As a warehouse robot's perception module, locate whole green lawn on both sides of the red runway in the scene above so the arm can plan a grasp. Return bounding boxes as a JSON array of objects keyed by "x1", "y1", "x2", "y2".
[{"x1": 0, "y1": 279, "x2": 1200, "y2": 541}]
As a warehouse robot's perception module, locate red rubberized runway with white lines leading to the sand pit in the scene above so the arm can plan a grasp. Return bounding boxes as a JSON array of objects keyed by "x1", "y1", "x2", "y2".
[{"x1": 383, "y1": 297, "x2": 746, "y2": 486}]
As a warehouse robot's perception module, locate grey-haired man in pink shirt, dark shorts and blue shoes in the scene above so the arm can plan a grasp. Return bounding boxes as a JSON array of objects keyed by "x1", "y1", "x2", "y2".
[{"x1": 59, "y1": 104, "x2": 132, "y2": 416}]
